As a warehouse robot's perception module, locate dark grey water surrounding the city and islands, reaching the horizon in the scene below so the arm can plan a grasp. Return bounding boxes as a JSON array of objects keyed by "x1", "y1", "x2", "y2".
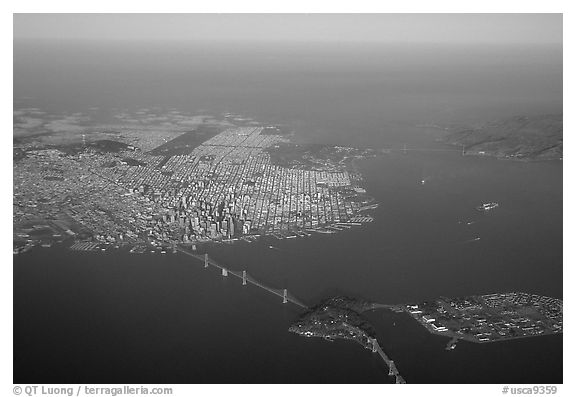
[{"x1": 14, "y1": 42, "x2": 562, "y2": 383}]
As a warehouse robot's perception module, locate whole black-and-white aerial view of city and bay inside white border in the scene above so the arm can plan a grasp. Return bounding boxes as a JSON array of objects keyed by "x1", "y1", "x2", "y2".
[{"x1": 12, "y1": 14, "x2": 564, "y2": 385}]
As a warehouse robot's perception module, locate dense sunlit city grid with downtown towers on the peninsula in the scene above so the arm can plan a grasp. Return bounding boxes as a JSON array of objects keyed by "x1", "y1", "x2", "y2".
[{"x1": 14, "y1": 126, "x2": 374, "y2": 251}]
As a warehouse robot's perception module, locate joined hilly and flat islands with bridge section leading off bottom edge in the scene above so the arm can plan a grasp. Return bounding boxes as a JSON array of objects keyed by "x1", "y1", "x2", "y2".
[{"x1": 289, "y1": 292, "x2": 563, "y2": 383}]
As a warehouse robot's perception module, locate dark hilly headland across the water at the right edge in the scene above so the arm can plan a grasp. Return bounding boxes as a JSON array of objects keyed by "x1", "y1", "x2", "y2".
[{"x1": 445, "y1": 114, "x2": 562, "y2": 160}]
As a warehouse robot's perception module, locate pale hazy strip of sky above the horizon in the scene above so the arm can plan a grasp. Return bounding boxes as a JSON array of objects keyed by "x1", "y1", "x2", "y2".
[{"x1": 14, "y1": 14, "x2": 562, "y2": 44}]
